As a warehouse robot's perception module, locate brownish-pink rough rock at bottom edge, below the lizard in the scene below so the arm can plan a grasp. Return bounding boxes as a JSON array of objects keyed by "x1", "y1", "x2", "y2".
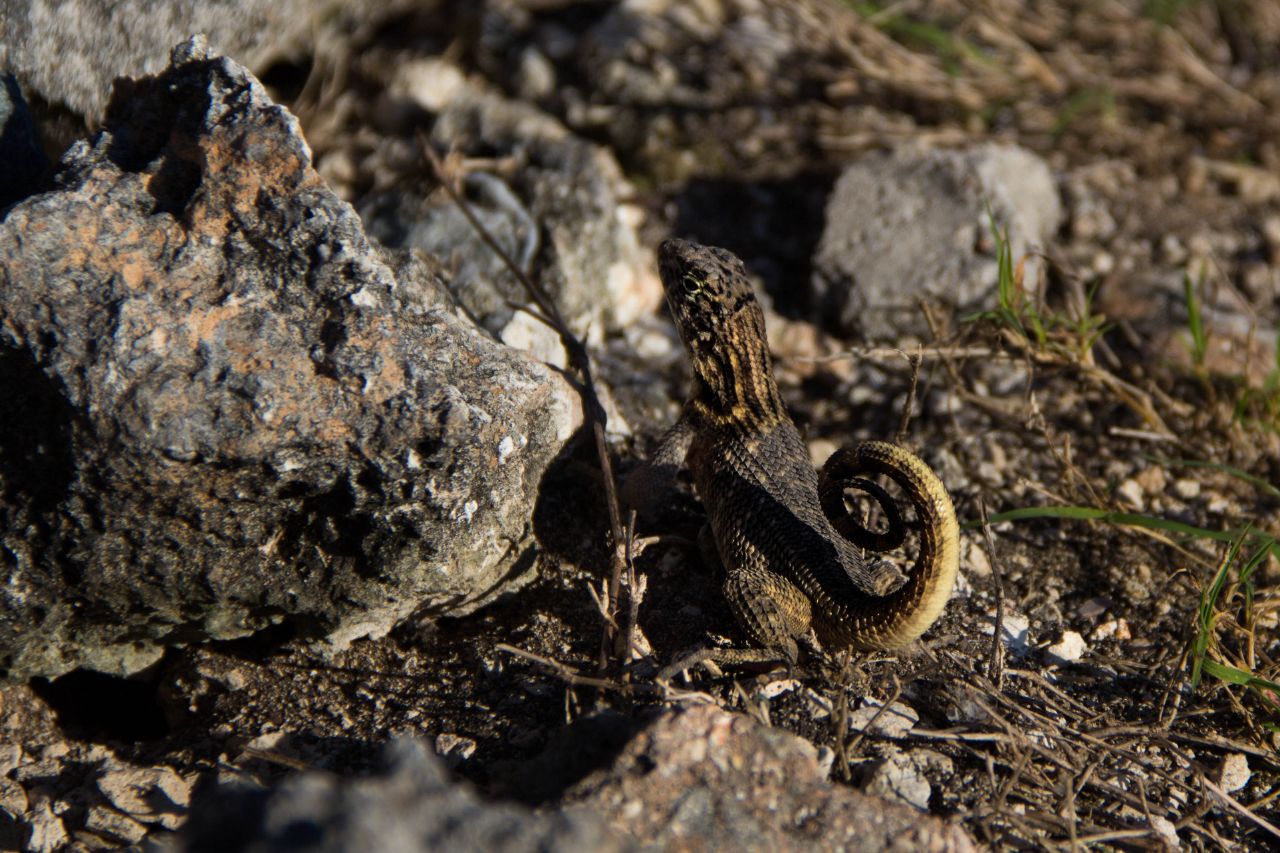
[{"x1": 567, "y1": 706, "x2": 975, "y2": 852}]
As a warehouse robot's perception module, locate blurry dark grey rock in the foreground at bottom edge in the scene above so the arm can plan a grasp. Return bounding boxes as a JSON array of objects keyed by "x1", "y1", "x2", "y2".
[{"x1": 178, "y1": 738, "x2": 631, "y2": 853}]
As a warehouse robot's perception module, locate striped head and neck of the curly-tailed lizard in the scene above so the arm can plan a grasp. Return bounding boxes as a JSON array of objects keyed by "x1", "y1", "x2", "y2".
[{"x1": 658, "y1": 240, "x2": 781, "y2": 419}]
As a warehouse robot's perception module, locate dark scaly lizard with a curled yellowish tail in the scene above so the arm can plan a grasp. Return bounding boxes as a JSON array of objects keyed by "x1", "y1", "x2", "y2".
[{"x1": 625, "y1": 238, "x2": 959, "y2": 680}]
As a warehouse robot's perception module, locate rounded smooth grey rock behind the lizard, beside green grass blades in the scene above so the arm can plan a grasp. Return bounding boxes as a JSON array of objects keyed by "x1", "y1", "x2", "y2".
[{"x1": 813, "y1": 145, "x2": 1061, "y2": 341}]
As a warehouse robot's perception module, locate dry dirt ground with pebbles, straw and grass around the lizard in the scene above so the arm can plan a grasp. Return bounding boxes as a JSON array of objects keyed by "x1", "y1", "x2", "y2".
[{"x1": 9, "y1": 0, "x2": 1280, "y2": 849}]
